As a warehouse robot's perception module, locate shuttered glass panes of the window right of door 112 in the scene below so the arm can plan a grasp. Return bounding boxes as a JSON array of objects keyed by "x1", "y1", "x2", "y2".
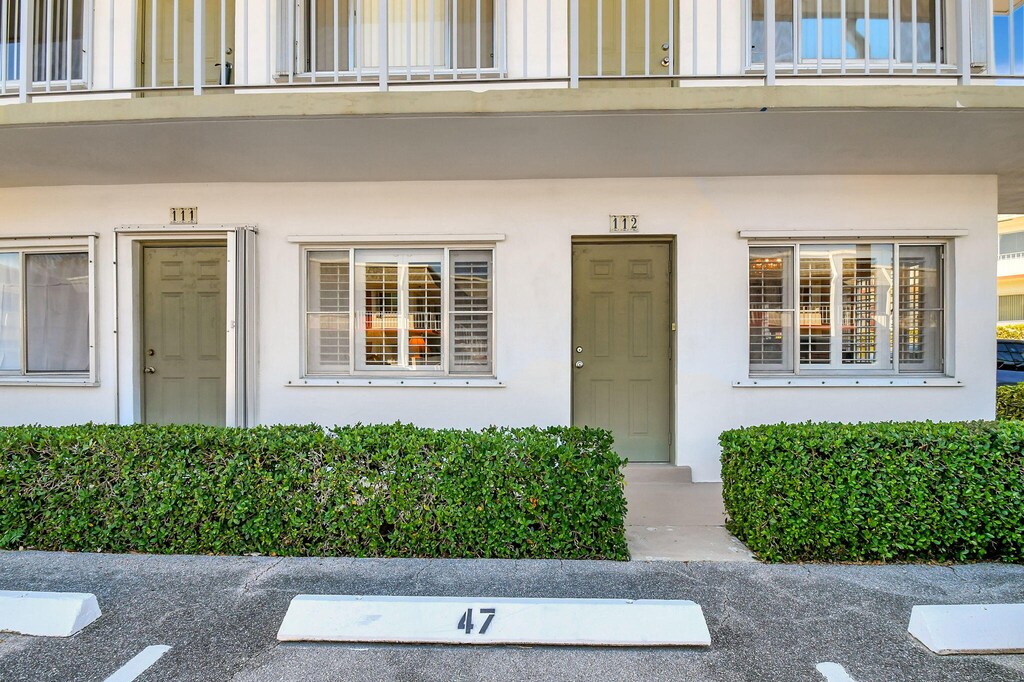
[{"x1": 749, "y1": 242, "x2": 945, "y2": 374}]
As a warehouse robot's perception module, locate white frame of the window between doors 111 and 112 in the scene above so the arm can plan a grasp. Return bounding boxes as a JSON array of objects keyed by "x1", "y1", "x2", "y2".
[{"x1": 293, "y1": 238, "x2": 498, "y2": 376}]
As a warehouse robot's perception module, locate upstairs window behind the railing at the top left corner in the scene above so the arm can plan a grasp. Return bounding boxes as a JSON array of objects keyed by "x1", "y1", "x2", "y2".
[{"x1": 0, "y1": 0, "x2": 85, "y2": 83}]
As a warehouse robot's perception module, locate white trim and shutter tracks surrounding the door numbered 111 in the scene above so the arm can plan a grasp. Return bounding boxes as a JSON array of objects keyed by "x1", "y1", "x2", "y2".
[{"x1": 114, "y1": 224, "x2": 256, "y2": 426}]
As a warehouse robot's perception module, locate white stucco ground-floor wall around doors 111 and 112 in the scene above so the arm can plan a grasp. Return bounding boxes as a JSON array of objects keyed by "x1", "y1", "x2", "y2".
[{"x1": 0, "y1": 176, "x2": 996, "y2": 480}]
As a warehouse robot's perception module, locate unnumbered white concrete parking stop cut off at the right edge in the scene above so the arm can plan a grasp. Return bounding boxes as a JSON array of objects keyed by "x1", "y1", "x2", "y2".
[{"x1": 908, "y1": 604, "x2": 1024, "y2": 655}]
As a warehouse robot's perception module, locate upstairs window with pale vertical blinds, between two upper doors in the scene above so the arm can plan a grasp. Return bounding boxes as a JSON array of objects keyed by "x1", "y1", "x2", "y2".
[{"x1": 292, "y1": 0, "x2": 497, "y2": 74}]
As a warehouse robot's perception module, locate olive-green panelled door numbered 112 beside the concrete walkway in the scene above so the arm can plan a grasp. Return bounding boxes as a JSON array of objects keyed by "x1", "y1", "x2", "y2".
[{"x1": 572, "y1": 242, "x2": 673, "y2": 462}]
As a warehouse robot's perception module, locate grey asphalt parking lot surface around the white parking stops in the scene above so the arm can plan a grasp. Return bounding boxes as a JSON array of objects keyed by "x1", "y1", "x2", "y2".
[{"x1": 0, "y1": 552, "x2": 1024, "y2": 682}]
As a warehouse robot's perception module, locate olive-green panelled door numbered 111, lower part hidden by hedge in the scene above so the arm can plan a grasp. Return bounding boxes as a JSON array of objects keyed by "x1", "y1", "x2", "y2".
[{"x1": 140, "y1": 246, "x2": 227, "y2": 426}]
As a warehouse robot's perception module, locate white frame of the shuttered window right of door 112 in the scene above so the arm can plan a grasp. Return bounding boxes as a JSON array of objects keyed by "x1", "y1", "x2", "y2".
[{"x1": 744, "y1": 236, "x2": 954, "y2": 379}]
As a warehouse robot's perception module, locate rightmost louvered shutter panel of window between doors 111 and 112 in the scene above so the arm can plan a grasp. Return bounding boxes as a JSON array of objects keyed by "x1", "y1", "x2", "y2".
[{"x1": 450, "y1": 251, "x2": 494, "y2": 374}]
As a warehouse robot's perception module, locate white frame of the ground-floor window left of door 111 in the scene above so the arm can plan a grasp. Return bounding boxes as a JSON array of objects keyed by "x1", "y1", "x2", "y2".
[{"x1": 0, "y1": 235, "x2": 99, "y2": 386}]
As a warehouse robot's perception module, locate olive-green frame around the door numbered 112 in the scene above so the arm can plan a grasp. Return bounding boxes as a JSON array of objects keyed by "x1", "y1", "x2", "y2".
[{"x1": 568, "y1": 235, "x2": 679, "y2": 466}]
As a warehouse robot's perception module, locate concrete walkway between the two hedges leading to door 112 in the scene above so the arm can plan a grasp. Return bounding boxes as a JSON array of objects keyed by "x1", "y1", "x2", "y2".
[{"x1": 625, "y1": 464, "x2": 755, "y2": 561}]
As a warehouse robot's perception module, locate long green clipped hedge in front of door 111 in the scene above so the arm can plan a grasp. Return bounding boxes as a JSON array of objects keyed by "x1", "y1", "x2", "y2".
[{"x1": 0, "y1": 424, "x2": 629, "y2": 559}]
